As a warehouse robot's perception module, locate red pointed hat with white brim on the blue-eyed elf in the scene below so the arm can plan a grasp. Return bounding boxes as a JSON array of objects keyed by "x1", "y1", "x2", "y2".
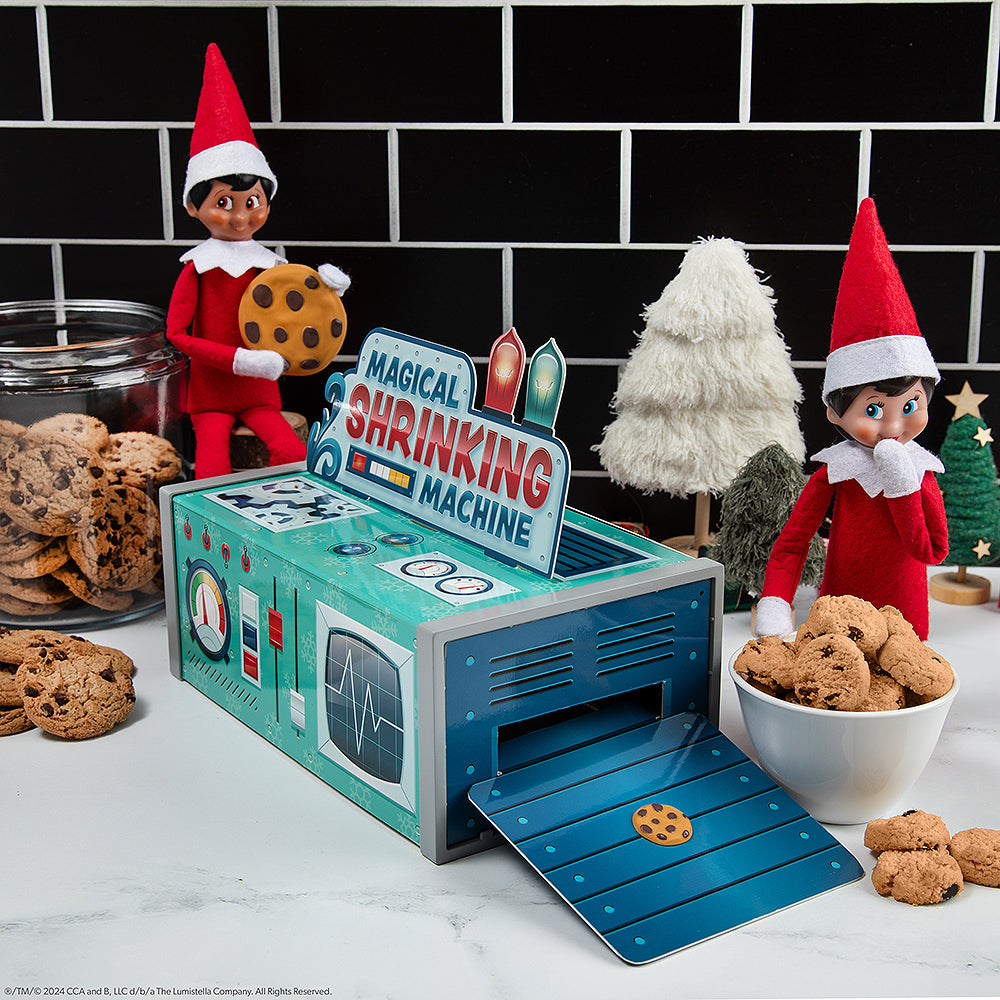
[{"x1": 823, "y1": 198, "x2": 941, "y2": 403}]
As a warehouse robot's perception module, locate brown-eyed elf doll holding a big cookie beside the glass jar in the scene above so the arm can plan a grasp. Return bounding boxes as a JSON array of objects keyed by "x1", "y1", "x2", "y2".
[{"x1": 167, "y1": 43, "x2": 349, "y2": 478}]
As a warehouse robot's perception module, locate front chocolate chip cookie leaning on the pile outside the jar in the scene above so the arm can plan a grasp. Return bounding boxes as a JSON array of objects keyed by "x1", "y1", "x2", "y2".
[{"x1": 17, "y1": 640, "x2": 135, "y2": 739}]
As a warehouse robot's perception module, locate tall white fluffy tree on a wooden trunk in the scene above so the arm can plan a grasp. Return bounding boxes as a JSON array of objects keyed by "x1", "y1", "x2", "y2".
[{"x1": 596, "y1": 238, "x2": 805, "y2": 547}]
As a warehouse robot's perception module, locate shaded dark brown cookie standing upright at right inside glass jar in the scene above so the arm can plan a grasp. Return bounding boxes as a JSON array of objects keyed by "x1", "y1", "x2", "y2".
[{"x1": 66, "y1": 486, "x2": 161, "y2": 590}]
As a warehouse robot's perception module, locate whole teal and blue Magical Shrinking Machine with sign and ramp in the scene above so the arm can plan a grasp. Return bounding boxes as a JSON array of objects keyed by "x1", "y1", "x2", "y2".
[{"x1": 161, "y1": 329, "x2": 861, "y2": 963}]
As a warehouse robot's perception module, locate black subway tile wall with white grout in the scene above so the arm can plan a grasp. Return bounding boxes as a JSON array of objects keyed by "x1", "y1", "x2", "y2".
[{"x1": 0, "y1": 0, "x2": 1000, "y2": 537}]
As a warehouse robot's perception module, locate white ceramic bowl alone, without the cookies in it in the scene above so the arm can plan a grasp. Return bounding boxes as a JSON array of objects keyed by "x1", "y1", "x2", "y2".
[{"x1": 729, "y1": 654, "x2": 958, "y2": 823}]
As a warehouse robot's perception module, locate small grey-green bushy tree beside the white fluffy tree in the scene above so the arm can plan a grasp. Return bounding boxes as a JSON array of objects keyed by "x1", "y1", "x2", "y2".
[{"x1": 708, "y1": 444, "x2": 826, "y2": 595}]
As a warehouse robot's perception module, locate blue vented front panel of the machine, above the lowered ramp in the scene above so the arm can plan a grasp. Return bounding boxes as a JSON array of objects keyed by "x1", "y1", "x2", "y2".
[{"x1": 445, "y1": 580, "x2": 712, "y2": 846}]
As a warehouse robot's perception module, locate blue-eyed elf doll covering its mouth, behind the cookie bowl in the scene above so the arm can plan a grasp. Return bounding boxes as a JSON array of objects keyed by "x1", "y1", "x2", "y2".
[{"x1": 756, "y1": 198, "x2": 948, "y2": 639}]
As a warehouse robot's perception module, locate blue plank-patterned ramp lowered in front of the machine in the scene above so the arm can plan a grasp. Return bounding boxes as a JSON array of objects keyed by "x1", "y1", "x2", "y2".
[{"x1": 469, "y1": 713, "x2": 863, "y2": 964}]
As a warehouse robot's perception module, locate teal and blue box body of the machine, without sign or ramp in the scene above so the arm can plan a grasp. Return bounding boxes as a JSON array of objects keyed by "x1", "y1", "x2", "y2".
[{"x1": 161, "y1": 467, "x2": 721, "y2": 863}]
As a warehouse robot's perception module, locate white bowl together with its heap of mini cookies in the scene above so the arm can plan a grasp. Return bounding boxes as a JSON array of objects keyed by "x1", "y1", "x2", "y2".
[{"x1": 729, "y1": 596, "x2": 959, "y2": 824}]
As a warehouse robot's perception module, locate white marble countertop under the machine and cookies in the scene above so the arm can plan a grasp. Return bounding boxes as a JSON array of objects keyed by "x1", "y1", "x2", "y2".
[{"x1": 0, "y1": 569, "x2": 1000, "y2": 1000}]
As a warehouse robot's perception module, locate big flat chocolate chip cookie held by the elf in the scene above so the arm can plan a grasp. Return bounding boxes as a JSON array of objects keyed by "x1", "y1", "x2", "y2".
[{"x1": 239, "y1": 264, "x2": 347, "y2": 375}]
